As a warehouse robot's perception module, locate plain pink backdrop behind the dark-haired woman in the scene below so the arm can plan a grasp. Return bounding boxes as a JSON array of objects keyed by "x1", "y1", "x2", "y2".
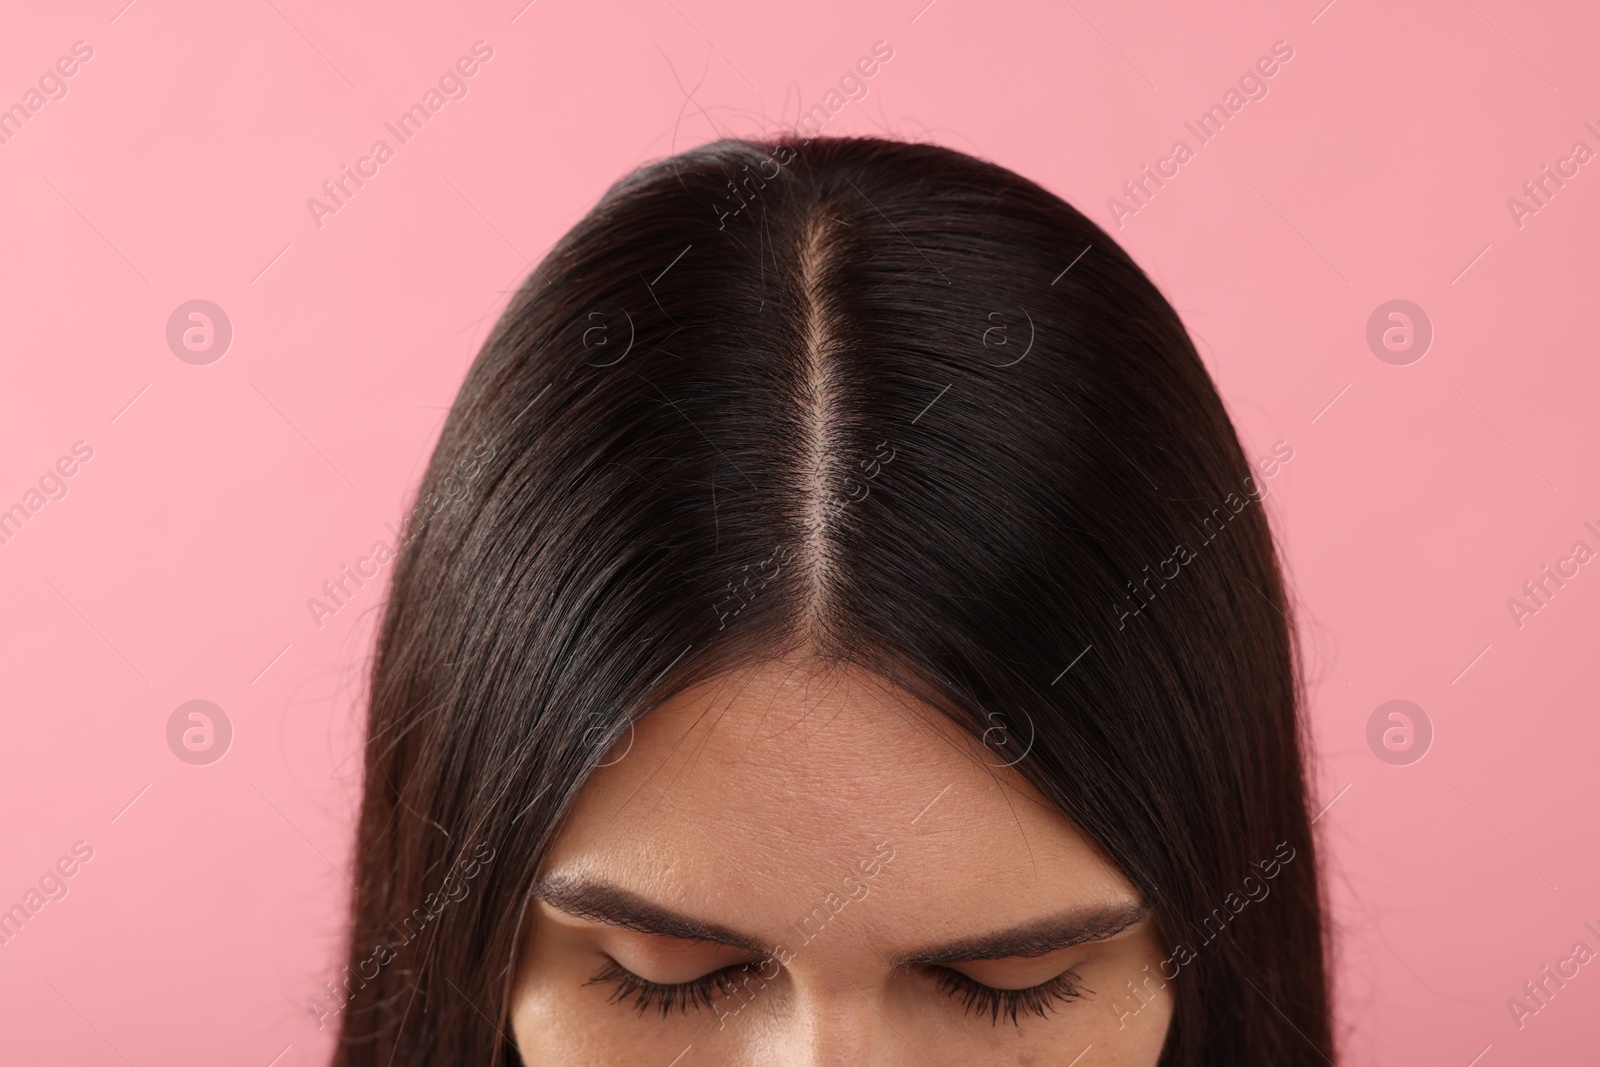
[{"x1": 0, "y1": 0, "x2": 1600, "y2": 1067}]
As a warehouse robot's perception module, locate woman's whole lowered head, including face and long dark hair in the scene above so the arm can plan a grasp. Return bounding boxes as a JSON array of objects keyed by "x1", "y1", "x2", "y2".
[{"x1": 338, "y1": 139, "x2": 1331, "y2": 1067}]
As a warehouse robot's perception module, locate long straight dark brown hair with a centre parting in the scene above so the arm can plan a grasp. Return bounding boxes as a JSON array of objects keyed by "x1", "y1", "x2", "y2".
[{"x1": 323, "y1": 138, "x2": 1334, "y2": 1067}]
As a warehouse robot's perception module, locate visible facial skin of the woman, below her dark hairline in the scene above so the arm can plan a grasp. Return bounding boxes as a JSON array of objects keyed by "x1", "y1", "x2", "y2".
[{"x1": 512, "y1": 661, "x2": 1176, "y2": 1067}]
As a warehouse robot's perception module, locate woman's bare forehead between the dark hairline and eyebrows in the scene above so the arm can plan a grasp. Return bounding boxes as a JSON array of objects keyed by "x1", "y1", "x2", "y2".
[{"x1": 546, "y1": 661, "x2": 1134, "y2": 931}]
